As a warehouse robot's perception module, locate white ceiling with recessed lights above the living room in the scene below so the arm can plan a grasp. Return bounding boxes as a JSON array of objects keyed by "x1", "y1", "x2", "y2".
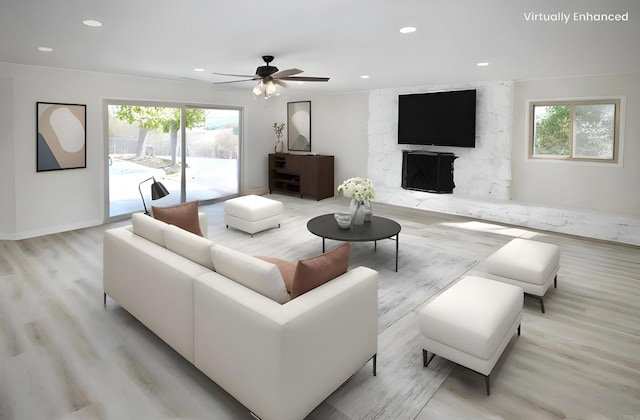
[{"x1": 0, "y1": 0, "x2": 640, "y2": 92}]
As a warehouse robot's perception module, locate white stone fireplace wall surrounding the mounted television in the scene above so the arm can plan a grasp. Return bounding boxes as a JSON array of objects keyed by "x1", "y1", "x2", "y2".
[{"x1": 368, "y1": 82, "x2": 513, "y2": 202}]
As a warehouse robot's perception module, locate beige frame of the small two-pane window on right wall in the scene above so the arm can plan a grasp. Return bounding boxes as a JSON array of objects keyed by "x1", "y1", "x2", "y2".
[{"x1": 527, "y1": 97, "x2": 624, "y2": 165}]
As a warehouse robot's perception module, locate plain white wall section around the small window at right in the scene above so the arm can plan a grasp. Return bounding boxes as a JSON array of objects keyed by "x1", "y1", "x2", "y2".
[{"x1": 511, "y1": 73, "x2": 640, "y2": 216}]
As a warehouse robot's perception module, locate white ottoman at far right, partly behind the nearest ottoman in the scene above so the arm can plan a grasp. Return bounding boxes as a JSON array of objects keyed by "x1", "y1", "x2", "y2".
[{"x1": 485, "y1": 238, "x2": 560, "y2": 313}]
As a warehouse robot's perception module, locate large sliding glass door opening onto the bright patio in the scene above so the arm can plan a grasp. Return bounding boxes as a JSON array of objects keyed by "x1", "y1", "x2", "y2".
[{"x1": 106, "y1": 102, "x2": 241, "y2": 218}]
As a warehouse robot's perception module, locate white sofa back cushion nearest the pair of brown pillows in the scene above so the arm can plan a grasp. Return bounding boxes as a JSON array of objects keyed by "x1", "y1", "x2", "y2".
[{"x1": 211, "y1": 245, "x2": 289, "y2": 303}]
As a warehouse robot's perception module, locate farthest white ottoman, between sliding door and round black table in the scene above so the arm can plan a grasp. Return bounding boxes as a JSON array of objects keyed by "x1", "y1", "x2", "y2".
[{"x1": 224, "y1": 195, "x2": 282, "y2": 236}]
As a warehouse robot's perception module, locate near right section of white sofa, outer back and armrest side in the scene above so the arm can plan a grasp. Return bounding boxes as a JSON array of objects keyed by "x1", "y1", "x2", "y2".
[{"x1": 194, "y1": 267, "x2": 378, "y2": 420}]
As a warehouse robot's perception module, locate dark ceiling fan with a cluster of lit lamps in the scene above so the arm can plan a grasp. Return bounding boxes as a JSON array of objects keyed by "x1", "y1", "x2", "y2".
[{"x1": 213, "y1": 55, "x2": 329, "y2": 98}]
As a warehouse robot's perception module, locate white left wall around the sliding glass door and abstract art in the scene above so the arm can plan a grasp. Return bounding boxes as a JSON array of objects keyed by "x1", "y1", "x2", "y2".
[{"x1": 0, "y1": 63, "x2": 272, "y2": 239}]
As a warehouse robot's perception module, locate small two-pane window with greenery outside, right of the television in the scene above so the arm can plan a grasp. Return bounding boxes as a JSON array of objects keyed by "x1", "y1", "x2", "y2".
[{"x1": 529, "y1": 99, "x2": 620, "y2": 163}]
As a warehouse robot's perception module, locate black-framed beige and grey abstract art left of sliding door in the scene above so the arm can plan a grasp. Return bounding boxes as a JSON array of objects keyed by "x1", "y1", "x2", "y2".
[{"x1": 36, "y1": 102, "x2": 87, "y2": 172}]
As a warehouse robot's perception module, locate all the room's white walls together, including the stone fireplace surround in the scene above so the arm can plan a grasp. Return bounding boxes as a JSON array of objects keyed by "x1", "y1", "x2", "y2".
[{"x1": 0, "y1": 63, "x2": 640, "y2": 245}]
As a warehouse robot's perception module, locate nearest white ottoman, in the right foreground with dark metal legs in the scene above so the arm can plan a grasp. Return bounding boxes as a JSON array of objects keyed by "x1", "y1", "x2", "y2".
[{"x1": 418, "y1": 276, "x2": 524, "y2": 395}]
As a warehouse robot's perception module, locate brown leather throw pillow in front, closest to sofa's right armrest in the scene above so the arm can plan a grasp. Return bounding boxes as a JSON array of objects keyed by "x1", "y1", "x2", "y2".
[{"x1": 291, "y1": 242, "x2": 351, "y2": 299}]
